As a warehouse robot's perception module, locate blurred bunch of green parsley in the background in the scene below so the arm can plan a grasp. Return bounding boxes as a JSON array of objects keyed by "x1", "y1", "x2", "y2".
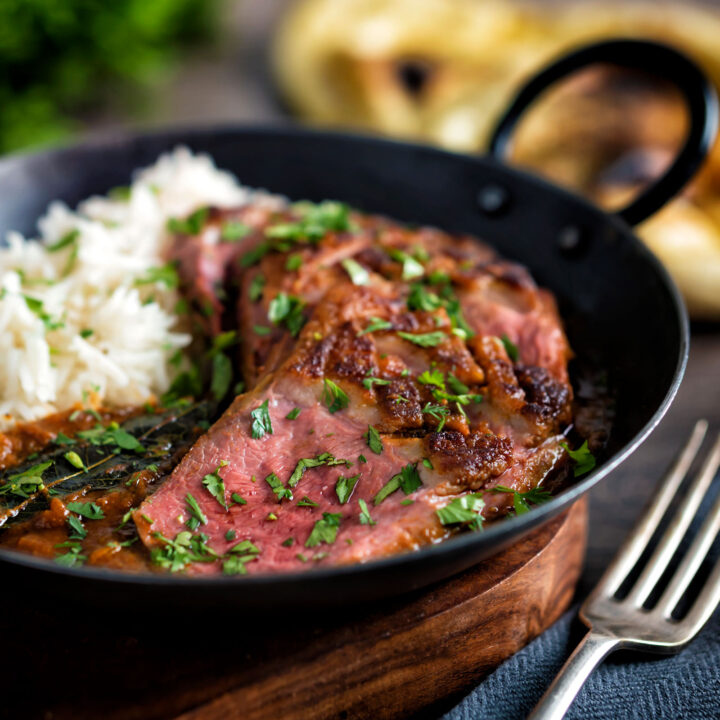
[{"x1": 0, "y1": 0, "x2": 218, "y2": 152}]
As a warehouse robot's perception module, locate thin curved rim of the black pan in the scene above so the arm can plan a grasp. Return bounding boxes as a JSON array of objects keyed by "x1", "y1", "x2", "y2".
[{"x1": 0, "y1": 123, "x2": 690, "y2": 596}]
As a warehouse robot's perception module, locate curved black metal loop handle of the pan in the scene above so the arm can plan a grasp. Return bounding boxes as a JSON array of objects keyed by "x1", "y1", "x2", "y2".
[{"x1": 489, "y1": 40, "x2": 718, "y2": 225}]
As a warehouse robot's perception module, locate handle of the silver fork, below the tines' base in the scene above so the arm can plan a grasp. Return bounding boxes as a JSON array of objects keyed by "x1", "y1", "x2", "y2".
[{"x1": 528, "y1": 630, "x2": 619, "y2": 720}]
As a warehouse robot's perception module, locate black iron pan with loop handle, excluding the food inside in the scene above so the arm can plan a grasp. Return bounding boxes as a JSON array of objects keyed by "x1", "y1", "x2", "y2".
[{"x1": 0, "y1": 40, "x2": 718, "y2": 609}]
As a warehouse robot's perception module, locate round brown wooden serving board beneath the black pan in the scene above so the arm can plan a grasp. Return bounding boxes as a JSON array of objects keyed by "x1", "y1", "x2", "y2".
[{"x1": 0, "y1": 501, "x2": 587, "y2": 720}]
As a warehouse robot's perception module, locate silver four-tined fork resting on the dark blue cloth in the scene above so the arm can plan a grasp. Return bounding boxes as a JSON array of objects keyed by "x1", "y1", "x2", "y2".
[{"x1": 528, "y1": 420, "x2": 720, "y2": 720}]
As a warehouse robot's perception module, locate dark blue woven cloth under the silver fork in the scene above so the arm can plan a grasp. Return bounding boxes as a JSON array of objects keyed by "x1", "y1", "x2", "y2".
[{"x1": 443, "y1": 607, "x2": 720, "y2": 720}]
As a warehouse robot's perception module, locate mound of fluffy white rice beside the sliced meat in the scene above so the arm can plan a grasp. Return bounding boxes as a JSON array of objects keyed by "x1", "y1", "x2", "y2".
[{"x1": 0, "y1": 148, "x2": 251, "y2": 429}]
